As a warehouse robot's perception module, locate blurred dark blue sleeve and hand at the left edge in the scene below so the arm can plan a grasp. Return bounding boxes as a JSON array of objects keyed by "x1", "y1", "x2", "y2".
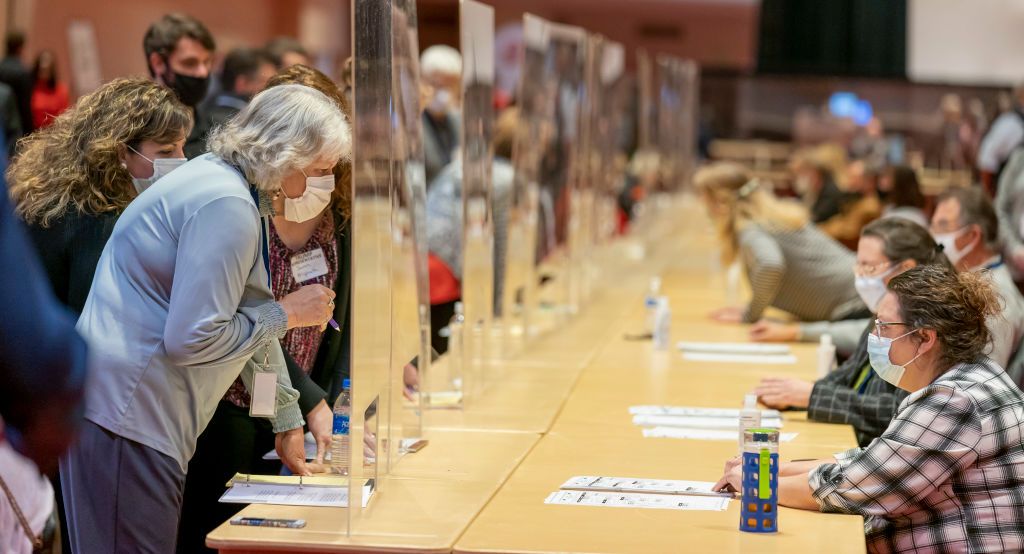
[{"x1": 0, "y1": 176, "x2": 86, "y2": 468}]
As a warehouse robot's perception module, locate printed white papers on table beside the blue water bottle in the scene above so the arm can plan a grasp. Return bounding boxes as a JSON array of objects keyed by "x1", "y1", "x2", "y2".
[{"x1": 544, "y1": 476, "x2": 733, "y2": 511}]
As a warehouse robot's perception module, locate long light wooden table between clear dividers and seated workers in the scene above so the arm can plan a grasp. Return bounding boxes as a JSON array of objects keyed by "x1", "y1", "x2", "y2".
[{"x1": 208, "y1": 200, "x2": 864, "y2": 553}]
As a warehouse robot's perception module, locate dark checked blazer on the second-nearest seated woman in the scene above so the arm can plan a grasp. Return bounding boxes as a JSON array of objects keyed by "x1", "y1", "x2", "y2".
[{"x1": 807, "y1": 321, "x2": 907, "y2": 446}]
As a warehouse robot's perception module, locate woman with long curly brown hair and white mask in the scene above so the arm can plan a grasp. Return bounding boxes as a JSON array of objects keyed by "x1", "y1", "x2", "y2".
[{"x1": 7, "y1": 79, "x2": 193, "y2": 313}]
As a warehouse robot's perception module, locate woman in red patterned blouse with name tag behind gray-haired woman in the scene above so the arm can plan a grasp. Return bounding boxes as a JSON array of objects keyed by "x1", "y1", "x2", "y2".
[{"x1": 177, "y1": 66, "x2": 352, "y2": 554}]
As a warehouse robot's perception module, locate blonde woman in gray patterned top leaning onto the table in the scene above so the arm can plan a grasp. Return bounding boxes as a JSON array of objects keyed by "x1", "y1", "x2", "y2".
[{"x1": 696, "y1": 163, "x2": 868, "y2": 323}]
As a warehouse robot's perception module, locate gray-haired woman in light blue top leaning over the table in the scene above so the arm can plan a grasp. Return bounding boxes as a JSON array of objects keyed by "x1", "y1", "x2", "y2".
[{"x1": 60, "y1": 85, "x2": 351, "y2": 553}]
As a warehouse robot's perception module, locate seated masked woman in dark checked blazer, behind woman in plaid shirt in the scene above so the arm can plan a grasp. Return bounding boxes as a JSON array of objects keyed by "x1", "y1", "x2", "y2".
[{"x1": 756, "y1": 218, "x2": 952, "y2": 446}]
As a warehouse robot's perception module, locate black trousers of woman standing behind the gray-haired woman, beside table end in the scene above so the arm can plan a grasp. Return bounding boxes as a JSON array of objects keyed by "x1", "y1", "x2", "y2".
[{"x1": 177, "y1": 400, "x2": 281, "y2": 554}]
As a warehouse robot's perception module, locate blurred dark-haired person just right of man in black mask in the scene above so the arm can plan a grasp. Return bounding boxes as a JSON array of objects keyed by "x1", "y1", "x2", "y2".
[{"x1": 195, "y1": 48, "x2": 278, "y2": 151}]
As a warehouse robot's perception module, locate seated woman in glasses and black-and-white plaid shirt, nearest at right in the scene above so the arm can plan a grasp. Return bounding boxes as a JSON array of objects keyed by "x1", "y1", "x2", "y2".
[{"x1": 718, "y1": 265, "x2": 1024, "y2": 552}]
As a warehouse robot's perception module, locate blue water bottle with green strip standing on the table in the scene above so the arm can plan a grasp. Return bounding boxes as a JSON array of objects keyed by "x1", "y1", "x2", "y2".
[{"x1": 739, "y1": 428, "x2": 778, "y2": 532}]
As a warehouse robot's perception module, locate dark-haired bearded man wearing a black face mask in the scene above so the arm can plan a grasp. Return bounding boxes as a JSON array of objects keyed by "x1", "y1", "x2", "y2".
[{"x1": 142, "y1": 13, "x2": 217, "y2": 160}]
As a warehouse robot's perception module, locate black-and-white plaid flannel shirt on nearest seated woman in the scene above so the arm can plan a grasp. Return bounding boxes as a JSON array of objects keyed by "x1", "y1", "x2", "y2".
[{"x1": 809, "y1": 358, "x2": 1024, "y2": 552}]
